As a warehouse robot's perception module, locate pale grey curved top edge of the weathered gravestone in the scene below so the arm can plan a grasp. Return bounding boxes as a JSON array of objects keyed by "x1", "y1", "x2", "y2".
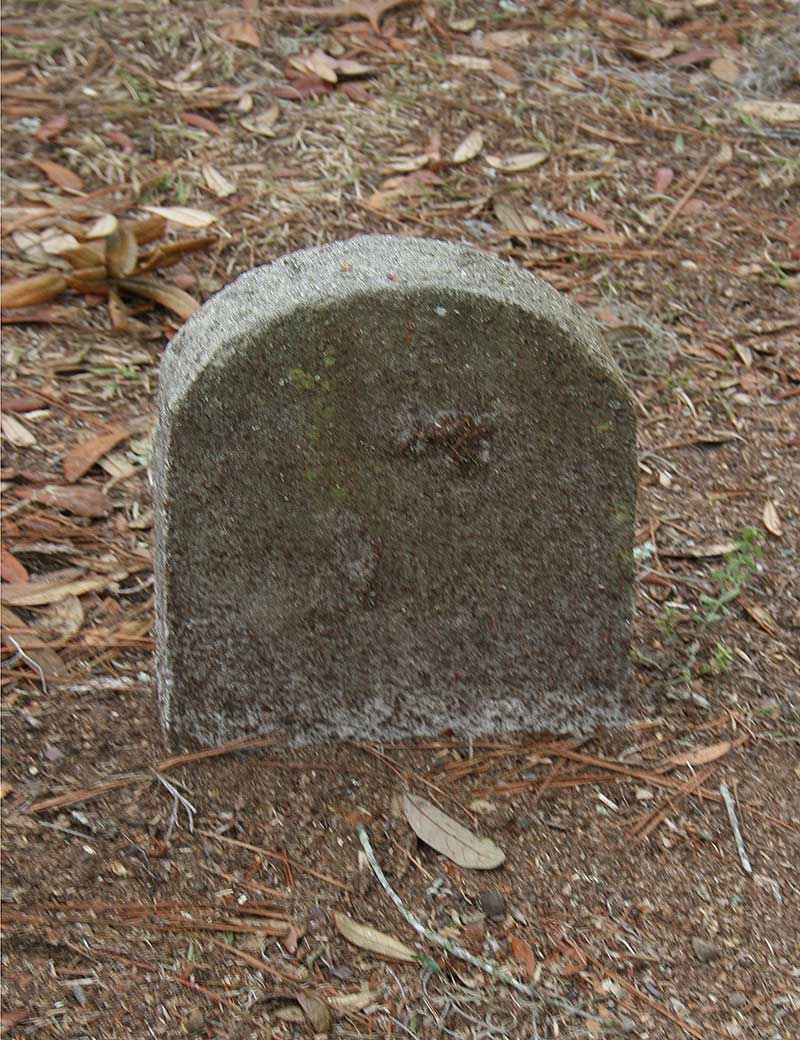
[{"x1": 160, "y1": 235, "x2": 628, "y2": 415}]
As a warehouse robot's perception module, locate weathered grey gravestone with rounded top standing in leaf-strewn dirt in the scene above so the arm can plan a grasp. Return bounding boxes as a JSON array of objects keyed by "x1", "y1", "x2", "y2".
[{"x1": 155, "y1": 236, "x2": 636, "y2": 743}]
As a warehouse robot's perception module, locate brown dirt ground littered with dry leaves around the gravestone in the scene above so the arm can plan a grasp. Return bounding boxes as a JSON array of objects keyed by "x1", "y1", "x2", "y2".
[{"x1": 0, "y1": 0, "x2": 800, "y2": 1040}]
